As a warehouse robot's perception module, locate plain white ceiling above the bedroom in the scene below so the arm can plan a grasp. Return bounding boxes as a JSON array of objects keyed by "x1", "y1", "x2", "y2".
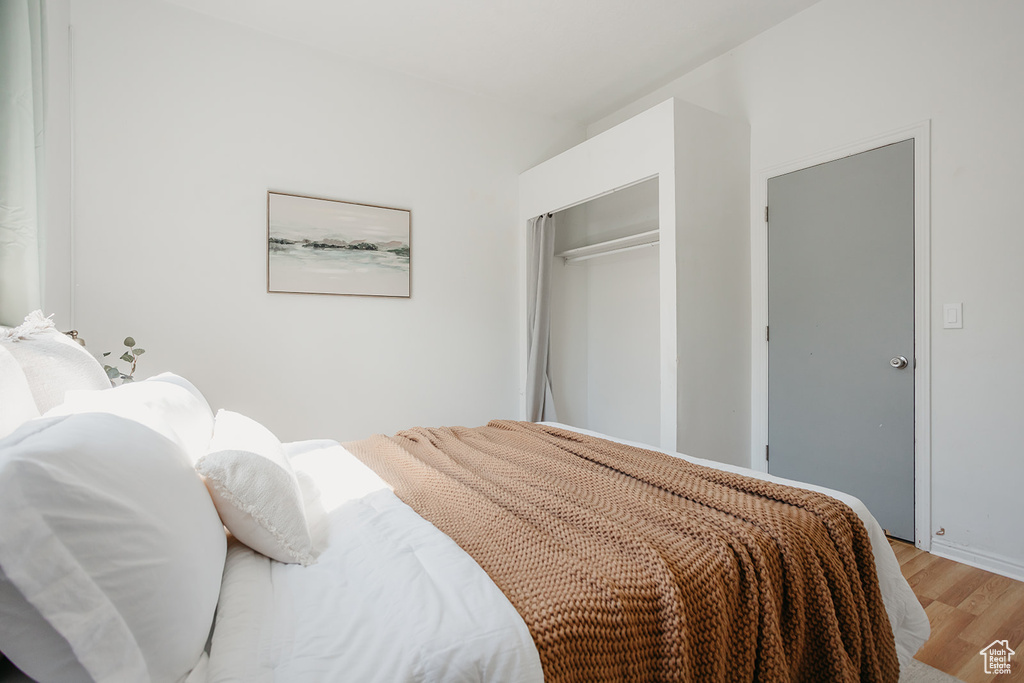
[{"x1": 163, "y1": 0, "x2": 817, "y2": 123}]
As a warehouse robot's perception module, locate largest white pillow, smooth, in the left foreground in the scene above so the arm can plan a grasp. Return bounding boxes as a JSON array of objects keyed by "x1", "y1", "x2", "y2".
[{"x1": 0, "y1": 414, "x2": 225, "y2": 683}]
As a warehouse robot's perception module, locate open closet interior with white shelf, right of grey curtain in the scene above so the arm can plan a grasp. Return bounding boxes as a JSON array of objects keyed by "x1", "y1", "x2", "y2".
[{"x1": 548, "y1": 176, "x2": 662, "y2": 443}]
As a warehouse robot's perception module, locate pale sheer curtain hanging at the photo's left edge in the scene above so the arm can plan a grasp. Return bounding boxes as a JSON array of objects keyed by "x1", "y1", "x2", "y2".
[{"x1": 0, "y1": 0, "x2": 45, "y2": 326}]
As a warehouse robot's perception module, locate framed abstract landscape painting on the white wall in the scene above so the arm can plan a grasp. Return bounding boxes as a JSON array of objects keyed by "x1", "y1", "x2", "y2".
[{"x1": 267, "y1": 193, "x2": 412, "y2": 297}]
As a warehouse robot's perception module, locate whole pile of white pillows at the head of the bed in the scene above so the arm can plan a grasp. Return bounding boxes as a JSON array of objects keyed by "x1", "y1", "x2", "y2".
[{"x1": 0, "y1": 316, "x2": 315, "y2": 683}]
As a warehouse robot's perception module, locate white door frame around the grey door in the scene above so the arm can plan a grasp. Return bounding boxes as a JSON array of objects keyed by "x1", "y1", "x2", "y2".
[{"x1": 751, "y1": 120, "x2": 932, "y2": 550}]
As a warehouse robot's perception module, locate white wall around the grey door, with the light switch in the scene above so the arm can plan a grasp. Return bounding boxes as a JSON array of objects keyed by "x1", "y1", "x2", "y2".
[{"x1": 588, "y1": 0, "x2": 1024, "y2": 575}]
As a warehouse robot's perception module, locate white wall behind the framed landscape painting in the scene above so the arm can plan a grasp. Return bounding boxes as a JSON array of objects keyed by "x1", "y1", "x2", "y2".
[{"x1": 59, "y1": 0, "x2": 583, "y2": 439}]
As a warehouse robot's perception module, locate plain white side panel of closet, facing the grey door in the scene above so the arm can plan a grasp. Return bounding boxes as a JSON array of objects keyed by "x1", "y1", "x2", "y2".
[{"x1": 675, "y1": 102, "x2": 751, "y2": 466}]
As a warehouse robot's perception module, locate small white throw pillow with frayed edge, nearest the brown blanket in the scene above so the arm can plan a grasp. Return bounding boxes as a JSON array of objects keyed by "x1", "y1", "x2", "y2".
[{"x1": 196, "y1": 411, "x2": 315, "y2": 565}]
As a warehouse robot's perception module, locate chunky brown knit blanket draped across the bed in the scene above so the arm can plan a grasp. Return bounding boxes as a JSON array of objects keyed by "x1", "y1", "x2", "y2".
[{"x1": 345, "y1": 421, "x2": 899, "y2": 683}]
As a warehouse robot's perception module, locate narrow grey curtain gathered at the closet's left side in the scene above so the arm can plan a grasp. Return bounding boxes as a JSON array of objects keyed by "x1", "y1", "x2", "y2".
[{"x1": 526, "y1": 214, "x2": 558, "y2": 422}]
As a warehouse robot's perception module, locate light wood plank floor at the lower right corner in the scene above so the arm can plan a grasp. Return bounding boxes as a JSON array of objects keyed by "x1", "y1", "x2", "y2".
[{"x1": 890, "y1": 541, "x2": 1024, "y2": 683}]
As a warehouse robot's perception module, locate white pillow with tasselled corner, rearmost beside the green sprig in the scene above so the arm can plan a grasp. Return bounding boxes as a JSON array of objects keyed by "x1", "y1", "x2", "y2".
[{"x1": 0, "y1": 311, "x2": 111, "y2": 414}]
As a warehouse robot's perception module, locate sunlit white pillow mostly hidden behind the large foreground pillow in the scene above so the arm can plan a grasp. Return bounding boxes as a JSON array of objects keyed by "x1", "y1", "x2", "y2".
[{"x1": 46, "y1": 373, "x2": 213, "y2": 463}]
